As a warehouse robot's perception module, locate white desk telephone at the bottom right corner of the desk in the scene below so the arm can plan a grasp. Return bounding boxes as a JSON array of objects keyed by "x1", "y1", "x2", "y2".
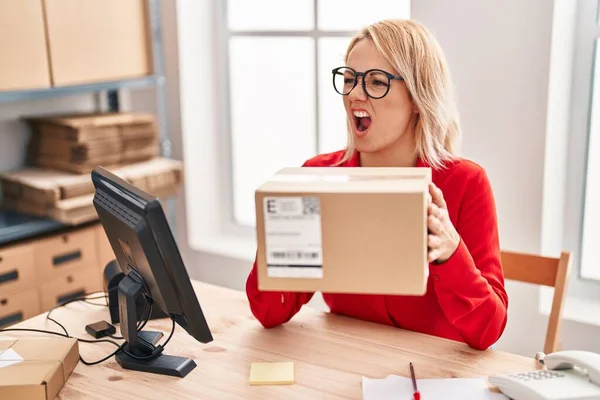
[{"x1": 489, "y1": 350, "x2": 600, "y2": 400}]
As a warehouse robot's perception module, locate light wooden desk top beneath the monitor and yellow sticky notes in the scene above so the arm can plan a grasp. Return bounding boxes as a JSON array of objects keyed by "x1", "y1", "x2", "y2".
[{"x1": 0, "y1": 282, "x2": 539, "y2": 400}]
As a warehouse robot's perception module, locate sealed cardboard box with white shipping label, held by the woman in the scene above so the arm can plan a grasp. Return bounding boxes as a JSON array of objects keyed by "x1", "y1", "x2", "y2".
[{"x1": 255, "y1": 167, "x2": 431, "y2": 295}]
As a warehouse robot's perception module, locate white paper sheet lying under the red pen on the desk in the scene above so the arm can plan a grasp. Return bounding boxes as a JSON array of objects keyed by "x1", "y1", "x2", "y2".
[{"x1": 362, "y1": 375, "x2": 508, "y2": 400}]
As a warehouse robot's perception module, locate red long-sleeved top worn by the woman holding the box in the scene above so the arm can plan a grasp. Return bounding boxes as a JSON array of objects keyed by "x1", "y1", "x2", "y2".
[{"x1": 246, "y1": 151, "x2": 508, "y2": 349}]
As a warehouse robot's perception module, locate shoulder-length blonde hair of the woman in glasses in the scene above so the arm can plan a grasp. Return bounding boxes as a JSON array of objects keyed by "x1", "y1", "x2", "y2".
[{"x1": 340, "y1": 20, "x2": 460, "y2": 168}]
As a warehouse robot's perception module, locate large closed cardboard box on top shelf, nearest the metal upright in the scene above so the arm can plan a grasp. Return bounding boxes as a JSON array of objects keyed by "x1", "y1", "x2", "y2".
[{"x1": 44, "y1": 0, "x2": 152, "y2": 86}]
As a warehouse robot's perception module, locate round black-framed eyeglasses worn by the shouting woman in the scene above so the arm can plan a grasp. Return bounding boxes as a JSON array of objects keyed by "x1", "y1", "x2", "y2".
[{"x1": 331, "y1": 67, "x2": 404, "y2": 99}]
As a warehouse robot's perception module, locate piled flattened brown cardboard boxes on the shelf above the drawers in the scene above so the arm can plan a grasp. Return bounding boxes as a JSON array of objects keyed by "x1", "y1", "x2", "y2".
[{"x1": 0, "y1": 112, "x2": 183, "y2": 225}]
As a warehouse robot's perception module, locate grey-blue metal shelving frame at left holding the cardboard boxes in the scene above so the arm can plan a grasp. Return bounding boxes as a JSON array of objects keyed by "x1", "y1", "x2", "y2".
[{"x1": 0, "y1": 0, "x2": 174, "y2": 246}]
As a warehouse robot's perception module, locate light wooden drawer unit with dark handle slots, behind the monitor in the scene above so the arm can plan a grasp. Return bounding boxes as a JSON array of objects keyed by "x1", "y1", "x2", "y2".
[{"x1": 0, "y1": 223, "x2": 114, "y2": 328}]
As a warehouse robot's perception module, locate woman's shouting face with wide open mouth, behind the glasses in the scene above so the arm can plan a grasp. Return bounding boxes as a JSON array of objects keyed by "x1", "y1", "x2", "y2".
[{"x1": 343, "y1": 39, "x2": 417, "y2": 153}]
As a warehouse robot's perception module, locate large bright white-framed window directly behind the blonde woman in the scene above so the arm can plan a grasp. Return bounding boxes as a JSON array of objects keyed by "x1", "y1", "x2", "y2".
[{"x1": 220, "y1": 0, "x2": 410, "y2": 227}]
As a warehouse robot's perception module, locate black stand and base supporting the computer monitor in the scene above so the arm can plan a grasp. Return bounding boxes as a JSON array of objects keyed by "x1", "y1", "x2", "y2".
[{"x1": 115, "y1": 270, "x2": 196, "y2": 378}]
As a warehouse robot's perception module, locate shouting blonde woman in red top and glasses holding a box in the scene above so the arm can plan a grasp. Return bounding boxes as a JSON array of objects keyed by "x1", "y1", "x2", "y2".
[{"x1": 246, "y1": 20, "x2": 508, "y2": 349}]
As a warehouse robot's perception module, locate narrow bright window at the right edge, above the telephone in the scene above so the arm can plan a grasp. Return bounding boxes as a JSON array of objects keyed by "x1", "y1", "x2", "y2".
[{"x1": 565, "y1": 2, "x2": 600, "y2": 288}]
